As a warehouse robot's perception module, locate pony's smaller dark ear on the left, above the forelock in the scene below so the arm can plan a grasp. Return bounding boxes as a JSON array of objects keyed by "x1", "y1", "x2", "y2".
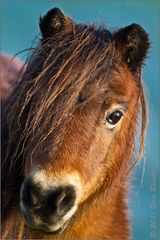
[{"x1": 39, "y1": 8, "x2": 73, "y2": 39}]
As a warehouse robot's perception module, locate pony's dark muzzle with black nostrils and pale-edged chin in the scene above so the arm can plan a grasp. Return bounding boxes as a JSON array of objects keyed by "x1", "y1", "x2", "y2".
[{"x1": 20, "y1": 177, "x2": 77, "y2": 234}]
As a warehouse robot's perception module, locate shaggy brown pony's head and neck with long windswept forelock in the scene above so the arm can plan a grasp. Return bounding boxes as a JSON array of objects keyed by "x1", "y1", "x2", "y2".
[{"x1": 2, "y1": 8, "x2": 149, "y2": 240}]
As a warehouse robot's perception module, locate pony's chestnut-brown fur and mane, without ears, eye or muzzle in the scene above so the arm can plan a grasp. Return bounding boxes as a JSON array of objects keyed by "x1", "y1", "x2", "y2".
[{"x1": 2, "y1": 8, "x2": 149, "y2": 240}]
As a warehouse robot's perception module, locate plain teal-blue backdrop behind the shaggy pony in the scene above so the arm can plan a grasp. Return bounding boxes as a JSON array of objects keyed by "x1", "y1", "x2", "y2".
[{"x1": 0, "y1": 0, "x2": 160, "y2": 240}]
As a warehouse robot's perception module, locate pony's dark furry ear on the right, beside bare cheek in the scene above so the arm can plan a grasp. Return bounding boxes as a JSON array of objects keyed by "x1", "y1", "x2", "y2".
[{"x1": 114, "y1": 23, "x2": 150, "y2": 73}]
